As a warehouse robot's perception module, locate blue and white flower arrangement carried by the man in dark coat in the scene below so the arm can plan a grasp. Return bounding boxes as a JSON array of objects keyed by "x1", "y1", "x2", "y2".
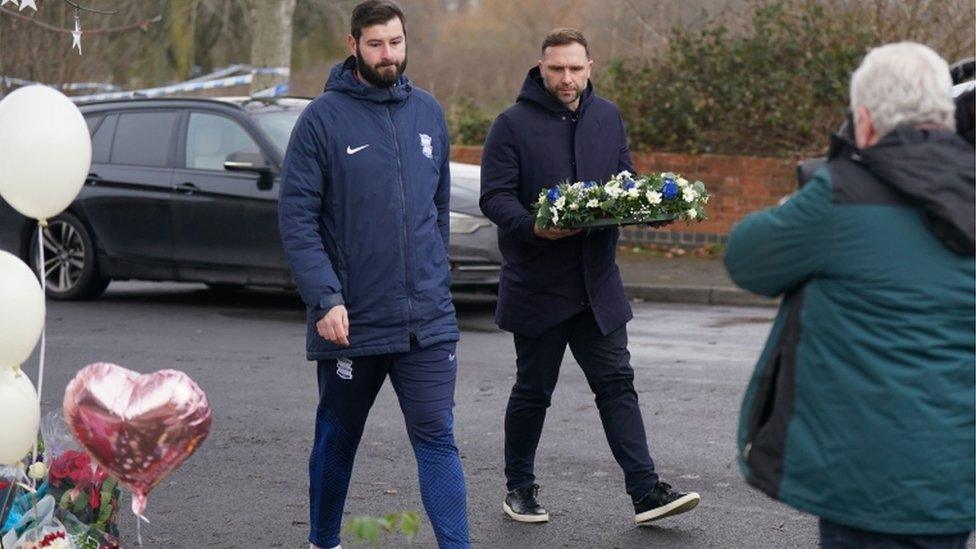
[{"x1": 536, "y1": 171, "x2": 708, "y2": 229}]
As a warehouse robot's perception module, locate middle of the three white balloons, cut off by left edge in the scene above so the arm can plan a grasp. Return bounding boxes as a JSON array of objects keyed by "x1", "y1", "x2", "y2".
[{"x1": 0, "y1": 250, "x2": 45, "y2": 368}]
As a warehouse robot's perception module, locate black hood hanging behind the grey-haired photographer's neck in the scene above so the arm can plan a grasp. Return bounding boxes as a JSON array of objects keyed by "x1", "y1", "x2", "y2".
[{"x1": 859, "y1": 126, "x2": 976, "y2": 255}]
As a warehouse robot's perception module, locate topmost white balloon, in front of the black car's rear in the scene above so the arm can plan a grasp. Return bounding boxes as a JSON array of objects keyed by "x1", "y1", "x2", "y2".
[{"x1": 0, "y1": 85, "x2": 91, "y2": 219}]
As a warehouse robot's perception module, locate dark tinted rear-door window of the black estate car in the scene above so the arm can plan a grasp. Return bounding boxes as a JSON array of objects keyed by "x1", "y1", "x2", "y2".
[{"x1": 111, "y1": 111, "x2": 177, "y2": 167}]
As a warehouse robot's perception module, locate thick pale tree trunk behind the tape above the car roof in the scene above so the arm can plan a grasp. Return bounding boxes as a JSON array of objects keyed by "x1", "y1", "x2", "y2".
[{"x1": 251, "y1": 0, "x2": 295, "y2": 94}]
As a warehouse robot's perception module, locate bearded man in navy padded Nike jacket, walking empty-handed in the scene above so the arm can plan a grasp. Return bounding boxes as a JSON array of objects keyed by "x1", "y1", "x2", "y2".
[{"x1": 278, "y1": 0, "x2": 470, "y2": 549}]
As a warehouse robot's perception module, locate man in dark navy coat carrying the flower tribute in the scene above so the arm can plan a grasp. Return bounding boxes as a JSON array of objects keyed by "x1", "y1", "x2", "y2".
[{"x1": 480, "y1": 29, "x2": 700, "y2": 524}]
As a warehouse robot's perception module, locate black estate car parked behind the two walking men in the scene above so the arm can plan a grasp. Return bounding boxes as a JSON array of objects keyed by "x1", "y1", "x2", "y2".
[{"x1": 0, "y1": 98, "x2": 501, "y2": 299}]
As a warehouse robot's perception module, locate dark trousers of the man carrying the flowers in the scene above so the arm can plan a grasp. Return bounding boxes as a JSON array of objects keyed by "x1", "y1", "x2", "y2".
[{"x1": 505, "y1": 309, "x2": 658, "y2": 501}]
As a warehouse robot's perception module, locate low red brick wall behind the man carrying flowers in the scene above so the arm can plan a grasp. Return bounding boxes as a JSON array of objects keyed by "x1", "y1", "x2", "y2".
[{"x1": 451, "y1": 147, "x2": 797, "y2": 244}]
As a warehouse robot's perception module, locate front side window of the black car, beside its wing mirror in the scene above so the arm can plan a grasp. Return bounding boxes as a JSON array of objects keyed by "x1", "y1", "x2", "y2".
[{"x1": 186, "y1": 112, "x2": 261, "y2": 170}]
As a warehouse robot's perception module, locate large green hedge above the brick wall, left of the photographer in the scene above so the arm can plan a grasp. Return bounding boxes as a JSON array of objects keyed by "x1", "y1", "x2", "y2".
[{"x1": 600, "y1": 2, "x2": 872, "y2": 155}]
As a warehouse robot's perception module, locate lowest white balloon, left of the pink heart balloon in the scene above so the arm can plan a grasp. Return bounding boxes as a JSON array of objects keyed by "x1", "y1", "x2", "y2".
[{"x1": 0, "y1": 366, "x2": 41, "y2": 465}]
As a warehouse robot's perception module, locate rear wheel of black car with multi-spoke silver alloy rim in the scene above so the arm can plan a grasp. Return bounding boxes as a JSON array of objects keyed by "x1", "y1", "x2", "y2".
[{"x1": 28, "y1": 212, "x2": 110, "y2": 300}]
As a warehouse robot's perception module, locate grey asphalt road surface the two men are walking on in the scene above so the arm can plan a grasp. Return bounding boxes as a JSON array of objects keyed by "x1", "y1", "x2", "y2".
[{"x1": 25, "y1": 283, "x2": 817, "y2": 549}]
